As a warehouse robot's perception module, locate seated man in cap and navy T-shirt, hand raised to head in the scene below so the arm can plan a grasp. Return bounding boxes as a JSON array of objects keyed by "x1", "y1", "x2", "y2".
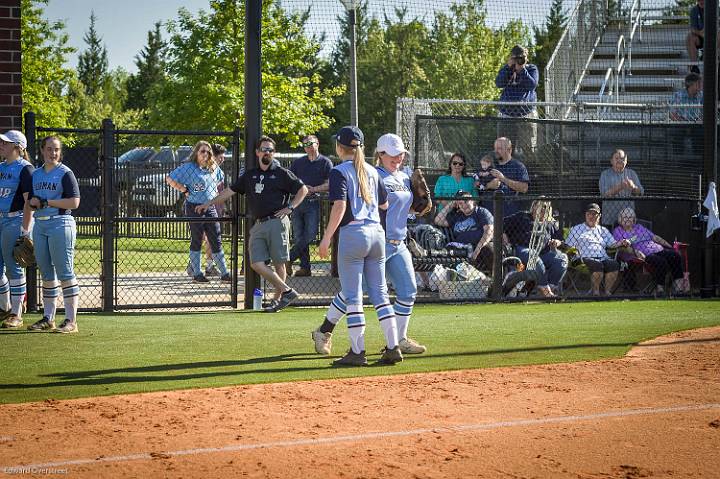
[{"x1": 435, "y1": 190, "x2": 493, "y2": 270}]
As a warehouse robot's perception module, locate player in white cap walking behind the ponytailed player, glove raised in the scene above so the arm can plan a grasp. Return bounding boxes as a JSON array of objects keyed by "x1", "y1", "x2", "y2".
[{"x1": 313, "y1": 133, "x2": 426, "y2": 354}]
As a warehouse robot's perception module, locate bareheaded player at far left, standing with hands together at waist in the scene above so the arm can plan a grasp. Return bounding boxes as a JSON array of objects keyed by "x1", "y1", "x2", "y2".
[{"x1": 28, "y1": 136, "x2": 80, "y2": 333}]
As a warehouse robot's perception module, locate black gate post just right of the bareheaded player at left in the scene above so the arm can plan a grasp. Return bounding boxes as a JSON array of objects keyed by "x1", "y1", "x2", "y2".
[{"x1": 100, "y1": 118, "x2": 115, "y2": 312}]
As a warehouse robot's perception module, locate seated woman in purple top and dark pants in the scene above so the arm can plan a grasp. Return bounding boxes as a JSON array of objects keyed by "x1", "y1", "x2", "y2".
[{"x1": 613, "y1": 208, "x2": 689, "y2": 295}]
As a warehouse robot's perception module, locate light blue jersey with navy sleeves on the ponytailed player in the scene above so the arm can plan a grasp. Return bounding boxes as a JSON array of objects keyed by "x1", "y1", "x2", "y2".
[{"x1": 329, "y1": 160, "x2": 387, "y2": 226}]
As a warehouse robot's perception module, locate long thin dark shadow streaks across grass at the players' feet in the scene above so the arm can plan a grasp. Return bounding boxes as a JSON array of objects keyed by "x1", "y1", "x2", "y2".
[{"x1": 0, "y1": 338, "x2": 720, "y2": 390}]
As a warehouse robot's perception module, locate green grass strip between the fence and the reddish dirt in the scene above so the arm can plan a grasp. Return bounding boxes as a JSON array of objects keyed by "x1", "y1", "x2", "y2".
[{"x1": 0, "y1": 300, "x2": 720, "y2": 403}]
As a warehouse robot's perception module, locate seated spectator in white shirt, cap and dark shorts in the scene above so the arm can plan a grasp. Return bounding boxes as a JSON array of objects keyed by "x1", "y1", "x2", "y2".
[{"x1": 565, "y1": 203, "x2": 630, "y2": 296}]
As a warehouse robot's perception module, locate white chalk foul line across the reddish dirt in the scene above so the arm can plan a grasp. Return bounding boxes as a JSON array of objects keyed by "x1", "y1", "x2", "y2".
[{"x1": 0, "y1": 403, "x2": 720, "y2": 472}]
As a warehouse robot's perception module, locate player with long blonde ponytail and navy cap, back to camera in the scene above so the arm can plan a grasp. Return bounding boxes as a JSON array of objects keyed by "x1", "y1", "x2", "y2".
[{"x1": 312, "y1": 126, "x2": 402, "y2": 366}]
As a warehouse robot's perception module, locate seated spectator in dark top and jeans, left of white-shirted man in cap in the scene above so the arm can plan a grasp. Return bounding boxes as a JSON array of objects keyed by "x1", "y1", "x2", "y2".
[{"x1": 503, "y1": 200, "x2": 568, "y2": 297}]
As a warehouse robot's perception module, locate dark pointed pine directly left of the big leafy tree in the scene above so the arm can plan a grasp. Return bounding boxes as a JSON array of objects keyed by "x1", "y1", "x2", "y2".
[{"x1": 125, "y1": 22, "x2": 166, "y2": 110}]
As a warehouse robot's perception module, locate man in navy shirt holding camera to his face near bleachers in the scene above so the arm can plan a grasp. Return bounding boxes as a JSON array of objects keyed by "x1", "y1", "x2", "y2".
[{"x1": 495, "y1": 45, "x2": 540, "y2": 156}]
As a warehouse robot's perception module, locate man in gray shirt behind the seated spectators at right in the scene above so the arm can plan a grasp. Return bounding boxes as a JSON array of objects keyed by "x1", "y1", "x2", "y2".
[{"x1": 600, "y1": 150, "x2": 645, "y2": 226}]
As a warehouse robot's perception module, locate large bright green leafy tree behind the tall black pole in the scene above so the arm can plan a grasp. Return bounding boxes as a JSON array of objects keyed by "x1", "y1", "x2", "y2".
[{"x1": 149, "y1": 0, "x2": 341, "y2": 144}]
